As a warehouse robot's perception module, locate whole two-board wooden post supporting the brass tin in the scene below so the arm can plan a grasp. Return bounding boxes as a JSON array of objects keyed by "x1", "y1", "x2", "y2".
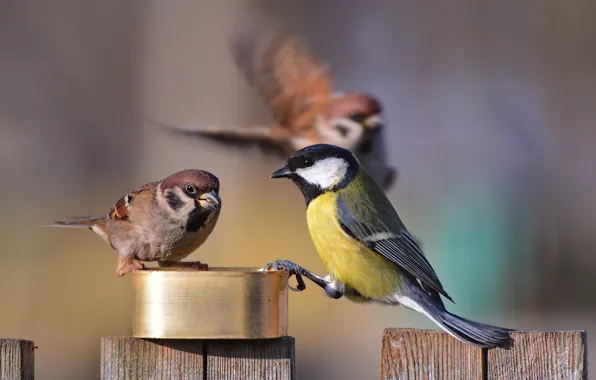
[{"x1": 101, "y1": 337, "x2": 296, "y2": 380}]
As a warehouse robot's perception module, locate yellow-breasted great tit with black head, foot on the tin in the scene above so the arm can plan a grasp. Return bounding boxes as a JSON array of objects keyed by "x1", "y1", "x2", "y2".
[{"x1": 264, "y1": 144, "x2": 513, "y2": 348}]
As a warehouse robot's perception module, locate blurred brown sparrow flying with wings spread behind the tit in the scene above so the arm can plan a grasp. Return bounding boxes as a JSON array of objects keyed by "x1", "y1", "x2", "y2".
[{"x1": 157, "y1": 19, "x2": 396, "y2": 189}]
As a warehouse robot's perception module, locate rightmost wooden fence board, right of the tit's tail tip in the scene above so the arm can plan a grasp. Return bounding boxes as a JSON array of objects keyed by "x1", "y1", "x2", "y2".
[{"x1": 487, "y1": 331, "x2": 588, "y2": 380}]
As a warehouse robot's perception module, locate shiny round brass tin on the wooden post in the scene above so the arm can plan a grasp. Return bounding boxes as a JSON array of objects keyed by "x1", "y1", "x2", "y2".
[{"x1": 133, "y1": 268, "x2": 288, "y2": 339}]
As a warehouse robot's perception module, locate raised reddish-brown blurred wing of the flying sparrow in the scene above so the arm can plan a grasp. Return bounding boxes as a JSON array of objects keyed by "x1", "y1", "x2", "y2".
[{"x1": 230, "y1": 25, "x2": 333, "y2": 128}]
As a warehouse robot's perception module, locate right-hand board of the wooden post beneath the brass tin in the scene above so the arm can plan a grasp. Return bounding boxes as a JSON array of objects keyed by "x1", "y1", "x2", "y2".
[{"x1": 205, "y1": 337, "x2": 296, "y2": 380}]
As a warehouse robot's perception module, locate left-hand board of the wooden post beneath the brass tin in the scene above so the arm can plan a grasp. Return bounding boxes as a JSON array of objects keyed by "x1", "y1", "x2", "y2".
[{"x1": 101, "y1": 337, "x2": 204, "y2": 380}]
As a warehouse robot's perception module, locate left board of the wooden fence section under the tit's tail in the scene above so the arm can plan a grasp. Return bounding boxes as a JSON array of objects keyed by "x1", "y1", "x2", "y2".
[{"x1": 381, "y1": 329, "x2": 483, "y2": 380}]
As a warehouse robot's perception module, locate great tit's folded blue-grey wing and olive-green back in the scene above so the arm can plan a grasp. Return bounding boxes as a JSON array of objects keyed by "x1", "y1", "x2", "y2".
[{"x1": 337, "y1": 186, "x2": 453, "y2": 302}]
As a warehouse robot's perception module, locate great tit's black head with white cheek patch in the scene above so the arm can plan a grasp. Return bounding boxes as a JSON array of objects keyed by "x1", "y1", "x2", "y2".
[{"x1": 271, "y1": 144, "x2": 360, "y2": 203}]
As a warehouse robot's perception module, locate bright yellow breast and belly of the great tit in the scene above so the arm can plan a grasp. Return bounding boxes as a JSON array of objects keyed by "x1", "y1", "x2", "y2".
[{"x1": 306, "y1": 192, "x2": 399, "y2": 299}]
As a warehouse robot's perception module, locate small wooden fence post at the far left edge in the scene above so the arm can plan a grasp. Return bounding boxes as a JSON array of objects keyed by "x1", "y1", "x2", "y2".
[{"x1": 0, "y1": 339, "x2": 35, "y2": 380}]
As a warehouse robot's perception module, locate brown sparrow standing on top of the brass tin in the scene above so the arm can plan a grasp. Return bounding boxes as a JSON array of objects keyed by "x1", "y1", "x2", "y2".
[{"x1": 51, "y1": 169, "x2": 221, "y2": 276}]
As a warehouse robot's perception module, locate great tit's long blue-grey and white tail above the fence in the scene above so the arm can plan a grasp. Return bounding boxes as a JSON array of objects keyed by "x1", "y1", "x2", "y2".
[{"x1": 399, "y1": 289, "x2": 514, "y2": 349}]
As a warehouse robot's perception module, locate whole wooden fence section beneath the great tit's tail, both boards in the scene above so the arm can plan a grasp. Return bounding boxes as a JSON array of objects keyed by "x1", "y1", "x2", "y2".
[{"x1": 381, "y1": 329, "x2": 588, "y2": 380}]
